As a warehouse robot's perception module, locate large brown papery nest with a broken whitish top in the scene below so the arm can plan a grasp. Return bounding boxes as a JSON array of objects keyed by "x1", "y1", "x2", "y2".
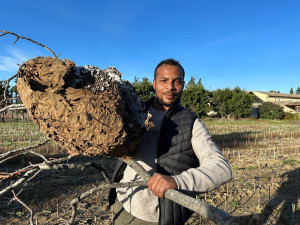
[{"x1": 17, "y1": 57, "x2": 147, "y2": 157}]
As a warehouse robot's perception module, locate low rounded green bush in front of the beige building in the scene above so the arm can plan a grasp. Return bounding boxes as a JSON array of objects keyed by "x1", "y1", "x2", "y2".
[{"x1": 258, "y1": 102, "x2": 284, "y2": 120}]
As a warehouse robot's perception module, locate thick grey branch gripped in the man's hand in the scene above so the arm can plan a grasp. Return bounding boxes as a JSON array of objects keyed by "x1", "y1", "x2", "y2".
[{"x1": 123, "y1": 159, "x2": 259, "y2": 225}]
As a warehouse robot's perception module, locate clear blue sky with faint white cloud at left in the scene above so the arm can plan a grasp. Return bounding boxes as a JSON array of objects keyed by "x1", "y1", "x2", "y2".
[{"x1": 0, "y1": 0, "x2": 300, "y2": 93}]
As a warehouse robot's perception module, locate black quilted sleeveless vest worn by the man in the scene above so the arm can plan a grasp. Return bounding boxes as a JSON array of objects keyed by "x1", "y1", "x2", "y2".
[{"x1": 109, "y1": 99, "x2": 199, "y2": 225}]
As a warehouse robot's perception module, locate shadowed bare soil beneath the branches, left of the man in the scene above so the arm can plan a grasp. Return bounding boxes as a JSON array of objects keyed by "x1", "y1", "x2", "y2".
[{"x1": 0, "y1": 156, "x2": 115, "y2": 224}]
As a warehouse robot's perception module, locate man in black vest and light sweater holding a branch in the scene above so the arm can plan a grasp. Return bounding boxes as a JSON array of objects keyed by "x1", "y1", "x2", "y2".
[{"x1": 109, "y1": 59, "x2": 232, "y2": 225}]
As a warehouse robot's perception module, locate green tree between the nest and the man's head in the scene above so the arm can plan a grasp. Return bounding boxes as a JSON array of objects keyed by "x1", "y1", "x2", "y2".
[{"x1": 132, "y1": 77, "x2": 155, "y2": 102}]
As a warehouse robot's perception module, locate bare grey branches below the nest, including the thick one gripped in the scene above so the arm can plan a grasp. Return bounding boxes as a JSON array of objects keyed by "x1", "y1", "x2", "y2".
[{"x1": 0, "y1": 139, "x2": 260, "y2": 225}]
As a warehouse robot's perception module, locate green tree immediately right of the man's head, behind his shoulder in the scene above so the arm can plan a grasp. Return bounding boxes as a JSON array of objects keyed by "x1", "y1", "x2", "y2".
[{"x1": 181, "y1": 77, "x2": 212, "y2": 118}]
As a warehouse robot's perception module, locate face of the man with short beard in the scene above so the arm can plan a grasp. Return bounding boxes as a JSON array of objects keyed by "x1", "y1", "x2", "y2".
[{"x1": 153, "y1": 64, "x2": 184, "y2": 110}]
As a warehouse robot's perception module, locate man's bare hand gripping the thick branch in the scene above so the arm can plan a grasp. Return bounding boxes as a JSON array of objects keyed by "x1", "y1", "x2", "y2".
[{"x1": 148, "y1": 173, "x2": 178, "y2": 198}]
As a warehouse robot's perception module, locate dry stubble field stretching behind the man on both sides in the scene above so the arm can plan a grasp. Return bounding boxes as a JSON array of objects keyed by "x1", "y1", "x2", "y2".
[{"x1": 0, "y1": 120, "x2": 300, "y2": 224}]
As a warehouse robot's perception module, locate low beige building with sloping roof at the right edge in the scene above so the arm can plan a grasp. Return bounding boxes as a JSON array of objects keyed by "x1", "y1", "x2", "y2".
[{"x1": 251, "y1": 91, "x2": 300, "y2": 113}]
